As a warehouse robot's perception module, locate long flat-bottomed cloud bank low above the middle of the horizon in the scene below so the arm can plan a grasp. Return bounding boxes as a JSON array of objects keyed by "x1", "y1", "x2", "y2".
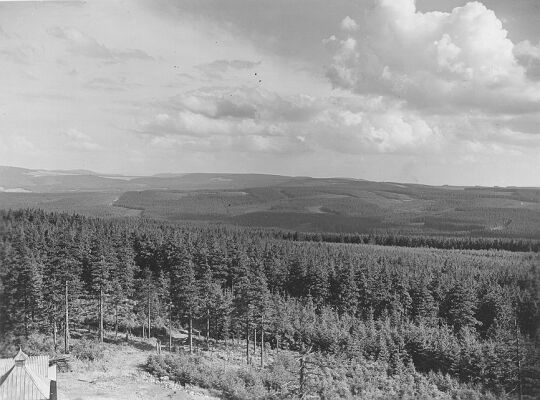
[{"x1": 138, "y1": 87, "x2": 441, "y2": 154}]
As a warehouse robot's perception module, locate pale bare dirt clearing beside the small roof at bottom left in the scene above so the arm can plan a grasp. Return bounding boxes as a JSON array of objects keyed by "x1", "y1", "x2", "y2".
[{"x1": 58, "y1": 346, "x2": 218, "y2": 400}]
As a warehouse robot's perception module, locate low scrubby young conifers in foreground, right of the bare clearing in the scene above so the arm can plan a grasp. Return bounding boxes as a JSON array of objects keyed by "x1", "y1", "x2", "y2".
[{"x1": 146, "y1": 354, "x2": 497, "y2": 400}]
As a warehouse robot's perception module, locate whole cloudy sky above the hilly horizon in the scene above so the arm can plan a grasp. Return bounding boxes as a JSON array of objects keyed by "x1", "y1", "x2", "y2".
[{"x1": 0, "y1": 0, "x2": 540, "y2": 186}]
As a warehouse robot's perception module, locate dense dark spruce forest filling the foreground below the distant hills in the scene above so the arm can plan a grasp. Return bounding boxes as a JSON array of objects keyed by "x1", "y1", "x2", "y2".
[{"x1": 0, "y1": 210, "x2": 540, "y2": 397}]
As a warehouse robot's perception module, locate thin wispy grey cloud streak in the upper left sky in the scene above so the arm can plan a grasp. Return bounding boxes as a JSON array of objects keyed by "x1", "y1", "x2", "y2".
[{"x1": 49, "y1": 26, "x2": 152, "y2": 62}]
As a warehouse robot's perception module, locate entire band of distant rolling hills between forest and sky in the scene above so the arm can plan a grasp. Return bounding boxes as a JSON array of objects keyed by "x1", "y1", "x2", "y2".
[{"x1": 0, "y1": 167, "x2": 540, "y2": 238}]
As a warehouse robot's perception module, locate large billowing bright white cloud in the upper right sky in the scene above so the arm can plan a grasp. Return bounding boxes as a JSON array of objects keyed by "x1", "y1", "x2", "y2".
[{"x1": 326, "y1": 0, "x2": 540, "y2": 113}]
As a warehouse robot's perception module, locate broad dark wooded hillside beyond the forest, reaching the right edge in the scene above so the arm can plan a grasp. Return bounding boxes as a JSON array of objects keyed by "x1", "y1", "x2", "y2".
[{"x1": 115, "y1": 179, "x2": 540, "y2": 237}]
